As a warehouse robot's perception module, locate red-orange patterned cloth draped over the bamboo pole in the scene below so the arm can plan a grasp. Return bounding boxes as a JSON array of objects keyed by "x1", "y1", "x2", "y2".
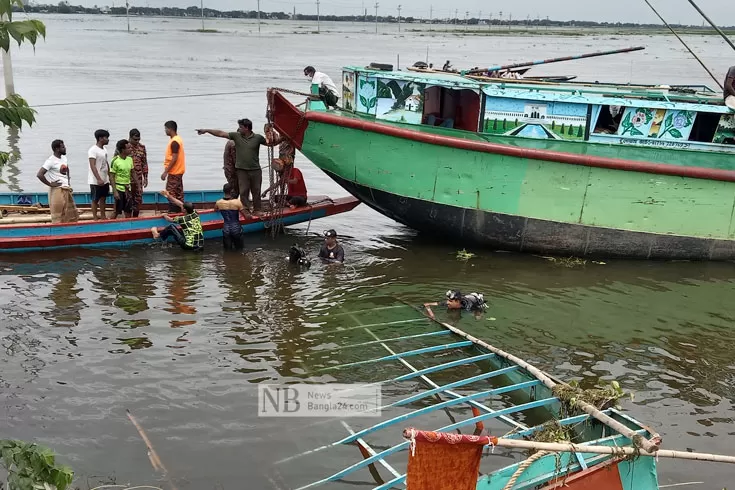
[{"x1": 403, "y1": 428, "x2": 498, "y2": 490}]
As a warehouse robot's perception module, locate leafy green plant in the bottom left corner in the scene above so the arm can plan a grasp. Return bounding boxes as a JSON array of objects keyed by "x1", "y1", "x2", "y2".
[{"x1": 0, "y1": 439, "x2": 74, "y2": 490}]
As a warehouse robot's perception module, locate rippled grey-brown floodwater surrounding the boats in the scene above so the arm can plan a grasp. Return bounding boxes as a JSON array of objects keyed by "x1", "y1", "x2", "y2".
[{"x1": 0, "y1": 16, "x2": 735, "y2": 489}]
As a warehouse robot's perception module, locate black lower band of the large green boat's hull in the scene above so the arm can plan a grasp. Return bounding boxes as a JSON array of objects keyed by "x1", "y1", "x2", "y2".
[{"x1": 327, "y1": 172, "x2": 735, "y2": 260}]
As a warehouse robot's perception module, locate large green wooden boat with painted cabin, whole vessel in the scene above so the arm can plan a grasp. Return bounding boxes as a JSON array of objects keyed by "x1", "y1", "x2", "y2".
[{"x1": 269, "y1": 54, "x2": 735, "y2": 260}]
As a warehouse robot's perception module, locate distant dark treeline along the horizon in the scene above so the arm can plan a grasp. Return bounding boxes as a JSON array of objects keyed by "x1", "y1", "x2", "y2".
[{"x1": 13, "y1": 1, "x2": 730, "y2": 29}]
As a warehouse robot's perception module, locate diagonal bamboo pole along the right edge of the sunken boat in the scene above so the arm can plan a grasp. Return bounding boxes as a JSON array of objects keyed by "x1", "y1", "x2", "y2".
[{"x1": 412, "y1": 304, "x2": 661, "y2": 453}]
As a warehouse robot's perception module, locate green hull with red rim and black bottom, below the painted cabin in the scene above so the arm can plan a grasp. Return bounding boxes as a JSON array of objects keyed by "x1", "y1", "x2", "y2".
[{"x1": 275, "y1": 92, "x2": 735, "y2": 260}]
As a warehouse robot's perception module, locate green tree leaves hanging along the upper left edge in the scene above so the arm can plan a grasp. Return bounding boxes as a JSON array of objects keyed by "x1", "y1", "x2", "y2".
[{"x1": 0, "y1": 0, "x2": 46, "y2": 165}]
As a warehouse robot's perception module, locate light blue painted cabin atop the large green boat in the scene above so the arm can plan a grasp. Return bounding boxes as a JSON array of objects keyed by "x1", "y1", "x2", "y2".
[{"x1": 341, "y1": 67, "x2": 735, "y2": 153}]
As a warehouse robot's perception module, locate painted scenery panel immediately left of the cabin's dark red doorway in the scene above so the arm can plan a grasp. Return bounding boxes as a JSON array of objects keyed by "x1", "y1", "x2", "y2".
[{"x1": 376, "y1": 78, "x2": 426, "y2": 124}]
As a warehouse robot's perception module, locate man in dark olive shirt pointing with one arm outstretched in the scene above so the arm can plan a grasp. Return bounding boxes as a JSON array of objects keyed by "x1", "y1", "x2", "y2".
[{"x1": 197, "y1": 119, "x2": 278, "y2": 214}]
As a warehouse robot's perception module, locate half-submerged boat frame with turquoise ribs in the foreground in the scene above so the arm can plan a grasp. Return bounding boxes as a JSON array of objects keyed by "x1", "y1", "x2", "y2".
[{"x1": 276, "y1": 305, "x2": 663, "y2": 490}]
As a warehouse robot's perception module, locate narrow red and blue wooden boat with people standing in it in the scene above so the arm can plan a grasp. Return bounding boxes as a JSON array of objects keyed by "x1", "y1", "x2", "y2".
[{"x1": 0, "y1": 190, "x2": 359, "y2": 253}]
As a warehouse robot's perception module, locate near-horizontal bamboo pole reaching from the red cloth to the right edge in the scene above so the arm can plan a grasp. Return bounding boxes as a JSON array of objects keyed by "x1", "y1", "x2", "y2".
[{"x1": 484, "y1": 438, "x2": 735, "y2": 464}]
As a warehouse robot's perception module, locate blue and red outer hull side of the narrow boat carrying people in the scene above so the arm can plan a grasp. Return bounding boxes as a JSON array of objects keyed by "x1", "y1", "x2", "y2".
[{"x1": 0, "y1": 191, "x2": 359, "y2": 254}]
